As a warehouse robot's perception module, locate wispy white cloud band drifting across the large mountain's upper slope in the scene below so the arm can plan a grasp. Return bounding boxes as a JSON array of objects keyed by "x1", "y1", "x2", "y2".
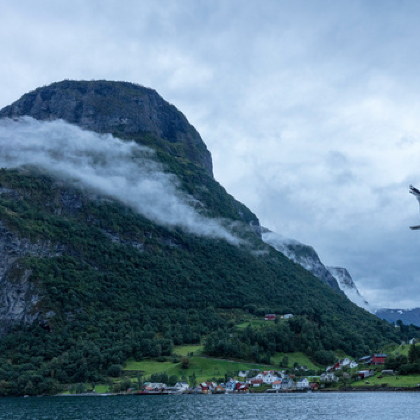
[{"x1": 0, "y1": 117, "x2": 239, "y2": 245}]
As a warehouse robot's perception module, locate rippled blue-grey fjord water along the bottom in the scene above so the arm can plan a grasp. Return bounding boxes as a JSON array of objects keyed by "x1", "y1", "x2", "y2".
[{"x1": 0, "y1": 392, "x2": 420, "y2": 420}]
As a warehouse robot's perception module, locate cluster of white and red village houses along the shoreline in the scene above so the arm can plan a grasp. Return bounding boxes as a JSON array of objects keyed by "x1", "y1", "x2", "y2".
[{"x1": 137, "y1": 353, "x2": 394, "y2": 395}]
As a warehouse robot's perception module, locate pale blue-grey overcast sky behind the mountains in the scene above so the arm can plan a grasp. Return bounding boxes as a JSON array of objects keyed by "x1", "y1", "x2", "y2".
[{"x1": 0, "y1": 0, "x2": 420, "y2": 308}]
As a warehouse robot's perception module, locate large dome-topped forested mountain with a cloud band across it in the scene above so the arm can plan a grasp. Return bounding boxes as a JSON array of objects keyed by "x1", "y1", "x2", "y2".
[{"x1": 0, "y1": 81, "x2": 397, "y2": 395}]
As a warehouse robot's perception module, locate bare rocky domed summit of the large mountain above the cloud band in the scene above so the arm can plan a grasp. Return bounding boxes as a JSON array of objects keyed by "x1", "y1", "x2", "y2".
[{"x1": 0, "y1": 80, "x2": 213, "y2": 176}]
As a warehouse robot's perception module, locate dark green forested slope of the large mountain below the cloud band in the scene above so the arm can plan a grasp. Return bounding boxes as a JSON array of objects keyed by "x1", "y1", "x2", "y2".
[{"x1": 0, "y1": 170, "x2": 393, "y2": 394}]
